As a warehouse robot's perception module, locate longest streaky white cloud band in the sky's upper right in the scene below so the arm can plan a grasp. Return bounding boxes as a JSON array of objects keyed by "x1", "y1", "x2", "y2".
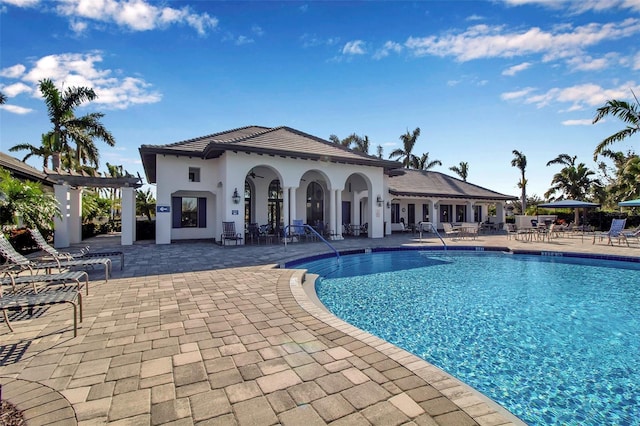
[{"x1": 405, "y1": 18, "x2": 640, "y2": 62}]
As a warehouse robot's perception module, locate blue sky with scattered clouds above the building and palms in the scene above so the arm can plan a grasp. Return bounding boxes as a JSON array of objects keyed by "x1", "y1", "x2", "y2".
[{"x1": 0, "y1": 0, "x2": 640, "y2": 196}]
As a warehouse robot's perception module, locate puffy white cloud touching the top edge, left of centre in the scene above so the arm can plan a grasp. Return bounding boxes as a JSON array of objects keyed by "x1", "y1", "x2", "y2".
[{"x1": 51, "y1": 0, "x2": 218, "y2": 35}]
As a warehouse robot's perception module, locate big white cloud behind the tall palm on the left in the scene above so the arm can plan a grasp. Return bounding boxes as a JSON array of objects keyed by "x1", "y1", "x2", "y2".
[{"x1": 3, "y1": 52, "x2": 162, "y2": 113}]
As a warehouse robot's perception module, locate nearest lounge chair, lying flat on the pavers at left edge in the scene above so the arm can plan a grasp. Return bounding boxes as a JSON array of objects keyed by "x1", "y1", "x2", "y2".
[{"x1": 0, "y1": 285, "x2": 82, "y2": 337}]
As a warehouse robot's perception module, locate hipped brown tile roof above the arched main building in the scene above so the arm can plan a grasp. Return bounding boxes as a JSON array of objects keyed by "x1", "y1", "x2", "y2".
[{"x1": 140, "y1": 126, "x2": 399, "y2": 182}]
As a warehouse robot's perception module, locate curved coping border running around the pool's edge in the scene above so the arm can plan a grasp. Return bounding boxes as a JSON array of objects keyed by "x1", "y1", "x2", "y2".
[{"x1": 280, "y1": 246, "x2": 640, "y2": 425}]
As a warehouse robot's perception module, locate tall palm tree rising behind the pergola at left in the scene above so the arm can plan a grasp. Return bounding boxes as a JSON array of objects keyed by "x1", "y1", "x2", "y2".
[{"x1": 40, "y1": 79, "x2": 115, "y2": 169}]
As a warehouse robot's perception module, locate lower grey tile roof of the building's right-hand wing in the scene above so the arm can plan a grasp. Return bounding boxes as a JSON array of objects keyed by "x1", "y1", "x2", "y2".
[{"x1": 389, "y1": 169, "x2": 517, "y2": 201}]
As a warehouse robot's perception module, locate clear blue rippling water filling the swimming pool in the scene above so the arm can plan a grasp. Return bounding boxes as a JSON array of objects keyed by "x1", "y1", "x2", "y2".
[{"x1": 296, "y1": 251, "x2": 640, "y2": 425}]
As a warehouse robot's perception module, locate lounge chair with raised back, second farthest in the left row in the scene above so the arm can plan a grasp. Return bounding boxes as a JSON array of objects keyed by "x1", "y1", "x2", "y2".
[{"x1": 0, "y1": 233, "x2": 111, "y2": 282}]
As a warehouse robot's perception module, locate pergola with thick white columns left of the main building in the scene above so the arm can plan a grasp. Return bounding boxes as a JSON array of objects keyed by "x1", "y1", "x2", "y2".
[{"x1": 44, "y1": 169, "x2": 142, "y2": 248}]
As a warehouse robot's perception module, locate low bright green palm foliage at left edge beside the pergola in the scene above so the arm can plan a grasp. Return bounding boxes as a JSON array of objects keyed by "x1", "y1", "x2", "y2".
[{"x1": 0, "y1": 167, "x2": 60, "y2": 229}]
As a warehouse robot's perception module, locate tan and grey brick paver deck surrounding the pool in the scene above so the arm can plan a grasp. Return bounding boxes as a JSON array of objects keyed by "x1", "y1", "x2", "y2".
[{"x1": 0, "y1": 234, "x2": 640, "y2": 426}]
